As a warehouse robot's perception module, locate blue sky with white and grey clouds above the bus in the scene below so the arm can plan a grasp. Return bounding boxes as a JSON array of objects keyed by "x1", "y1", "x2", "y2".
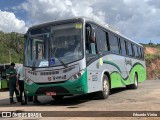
[{"x1": 0, "y1": 0, "x2": 160, "y2": 43}]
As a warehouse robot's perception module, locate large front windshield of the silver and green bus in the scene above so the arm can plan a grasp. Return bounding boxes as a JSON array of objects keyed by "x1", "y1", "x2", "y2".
[{"x1": 25, "y1": 23, "x2": 83, "y2": 67}]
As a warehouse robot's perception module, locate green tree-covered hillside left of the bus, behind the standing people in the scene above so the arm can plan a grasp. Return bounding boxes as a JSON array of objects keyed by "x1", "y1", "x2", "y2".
[{"x1": 0, "y1": 31, "x2": 24, "y2": 64}]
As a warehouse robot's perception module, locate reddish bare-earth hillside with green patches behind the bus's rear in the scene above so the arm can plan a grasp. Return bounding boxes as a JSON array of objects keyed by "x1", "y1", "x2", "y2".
[{"x1": 144, "y1": 45, "x2": 160, "y2": 80}]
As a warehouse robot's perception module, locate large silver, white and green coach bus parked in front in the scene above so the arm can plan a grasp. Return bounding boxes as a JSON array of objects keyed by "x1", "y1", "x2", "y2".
[{"x1": 24, "y1": 17, "x2": 146, "y2": 100}]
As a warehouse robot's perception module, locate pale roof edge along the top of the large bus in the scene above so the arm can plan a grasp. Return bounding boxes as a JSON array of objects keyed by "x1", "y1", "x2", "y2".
[{"x1": 29, "y1": 17, "x2": 143, "y2": 47}]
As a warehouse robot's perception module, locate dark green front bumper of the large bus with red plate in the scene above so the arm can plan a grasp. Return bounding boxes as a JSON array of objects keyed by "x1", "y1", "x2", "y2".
[{"x1": 24, "y1": 72, "x2": 88, "y2": 96}]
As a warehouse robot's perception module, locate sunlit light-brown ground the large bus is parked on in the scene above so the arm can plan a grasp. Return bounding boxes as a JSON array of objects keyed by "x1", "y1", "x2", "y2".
[{"x1": 0, "y1": 80, "x2": 160, "y2": 119}]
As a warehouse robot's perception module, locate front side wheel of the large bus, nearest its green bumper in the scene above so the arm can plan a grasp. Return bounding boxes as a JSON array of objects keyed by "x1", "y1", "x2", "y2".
[{"x1": 98, "y1": 74, "x2": 110, "y2": 99}]
